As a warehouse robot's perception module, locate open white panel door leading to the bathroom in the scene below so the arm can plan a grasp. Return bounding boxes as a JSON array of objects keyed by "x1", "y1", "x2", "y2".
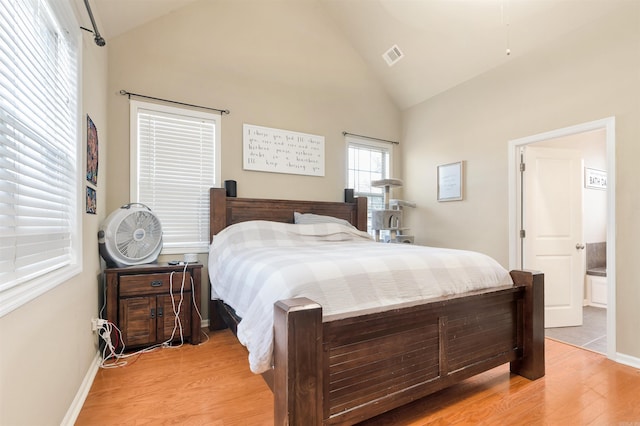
[{"x1": 523, "y1": 146, "x2": 585, "y2": 327}]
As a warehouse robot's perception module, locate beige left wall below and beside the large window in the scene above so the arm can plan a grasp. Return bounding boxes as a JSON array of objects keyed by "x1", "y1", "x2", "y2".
[{"x1": 0, "y1": 20, "x2": 108, "y2": 426}]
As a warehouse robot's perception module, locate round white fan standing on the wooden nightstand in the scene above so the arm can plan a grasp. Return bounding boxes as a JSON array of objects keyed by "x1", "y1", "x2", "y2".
[{"x1": 98, "y1": 203, "x2": 162, "y2": 268}]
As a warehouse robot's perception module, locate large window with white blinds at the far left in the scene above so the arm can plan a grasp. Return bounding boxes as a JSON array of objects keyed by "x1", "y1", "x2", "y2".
[{"x1": 0, "y1": 0, "x2": 82, "y2": 316}]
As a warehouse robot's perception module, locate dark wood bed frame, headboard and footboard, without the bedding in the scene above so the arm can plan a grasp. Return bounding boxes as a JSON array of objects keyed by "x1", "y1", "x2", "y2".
[{"x1": 209, "y1": 188, "x2": 544, "y2": 425}]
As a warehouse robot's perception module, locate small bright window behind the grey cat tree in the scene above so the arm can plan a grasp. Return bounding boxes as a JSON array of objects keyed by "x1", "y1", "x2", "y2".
[{"x1": 346, "y1": 136, "x2": 391, "y2": 233}]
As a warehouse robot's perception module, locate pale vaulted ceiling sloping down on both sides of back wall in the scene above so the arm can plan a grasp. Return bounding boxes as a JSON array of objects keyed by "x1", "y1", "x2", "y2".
[{"x1": 82, "y1": 0, "x2": 636, "y2": 109}]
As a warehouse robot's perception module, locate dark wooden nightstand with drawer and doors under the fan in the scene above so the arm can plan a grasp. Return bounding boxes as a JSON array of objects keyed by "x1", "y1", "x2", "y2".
[{"x1": 104, "y1": 263, "x2": 202, "y2": 349}]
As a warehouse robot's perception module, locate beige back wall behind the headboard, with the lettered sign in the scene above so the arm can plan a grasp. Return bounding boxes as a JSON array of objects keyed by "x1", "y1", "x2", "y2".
[{"x1": 107, "y1": 0, "x2": 401, "y2": 318}]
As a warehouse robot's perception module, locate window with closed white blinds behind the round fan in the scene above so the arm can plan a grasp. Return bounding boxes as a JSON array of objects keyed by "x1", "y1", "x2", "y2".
[{"x1": 131, "y1": 101, "x2": 220, "y2": 254}]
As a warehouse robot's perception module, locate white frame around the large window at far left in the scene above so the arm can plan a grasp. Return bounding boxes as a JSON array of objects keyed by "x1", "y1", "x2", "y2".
[{"x1": 0, "y1": 0, "x2": 86, "y2": 317}]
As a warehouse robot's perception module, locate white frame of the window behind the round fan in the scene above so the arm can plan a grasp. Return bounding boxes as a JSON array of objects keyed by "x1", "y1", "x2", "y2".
[{"x1": 130, "y1": 100, "x2": 222, "y2": 254}]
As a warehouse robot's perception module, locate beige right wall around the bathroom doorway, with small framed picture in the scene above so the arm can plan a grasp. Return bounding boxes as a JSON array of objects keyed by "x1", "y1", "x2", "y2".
[{"x1": 402, "y1": 2, "x2": 640, "y2": 359}]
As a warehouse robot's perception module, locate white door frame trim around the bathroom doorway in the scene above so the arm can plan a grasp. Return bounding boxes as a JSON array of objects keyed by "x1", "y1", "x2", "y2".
[{"x1": 508, "y1": 117, "x2": 616, "y2": 360}]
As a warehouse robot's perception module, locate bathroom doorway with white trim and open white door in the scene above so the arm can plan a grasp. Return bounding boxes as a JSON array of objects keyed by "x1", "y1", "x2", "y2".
[{"x1": 509, "y1": 118, "x2": 615, "y2": 358}]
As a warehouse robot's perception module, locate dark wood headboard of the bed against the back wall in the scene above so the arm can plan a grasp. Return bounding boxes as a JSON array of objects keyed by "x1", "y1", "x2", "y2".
[{"x1": 209, "y1": 188, "x2": 367, "y2": 241}]
